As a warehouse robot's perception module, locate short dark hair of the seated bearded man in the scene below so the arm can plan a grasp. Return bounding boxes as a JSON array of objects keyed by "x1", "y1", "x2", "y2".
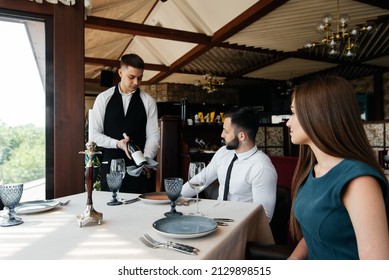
[{"x1": 224, "y1": 107, "x2": 259, "y2": 141}]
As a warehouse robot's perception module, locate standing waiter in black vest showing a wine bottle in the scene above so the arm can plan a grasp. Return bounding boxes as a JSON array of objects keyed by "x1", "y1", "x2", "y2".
[{"x1": 92, "y1": 54, "x2": 160, "y2": 193}]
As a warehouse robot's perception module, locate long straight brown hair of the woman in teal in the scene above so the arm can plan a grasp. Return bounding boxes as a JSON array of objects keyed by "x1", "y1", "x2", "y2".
[{"x1": 290, "y1": 76, "x2": 386, "y2": 240}]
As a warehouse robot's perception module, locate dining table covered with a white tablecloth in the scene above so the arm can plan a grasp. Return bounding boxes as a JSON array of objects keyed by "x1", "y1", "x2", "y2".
[{"x1": 0, "y1": 191, "x2": 274, "y2": 260}]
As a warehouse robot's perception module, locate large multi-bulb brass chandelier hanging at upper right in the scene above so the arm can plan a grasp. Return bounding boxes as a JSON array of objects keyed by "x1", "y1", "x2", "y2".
[{"x1": 304, "y1": 0, "x2": 375, "y2": 59}]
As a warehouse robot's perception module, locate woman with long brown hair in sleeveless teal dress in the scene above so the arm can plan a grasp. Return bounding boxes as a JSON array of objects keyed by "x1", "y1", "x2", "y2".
[{"x1": 287, "y1": 77, "x2": 389, "y2": 260}]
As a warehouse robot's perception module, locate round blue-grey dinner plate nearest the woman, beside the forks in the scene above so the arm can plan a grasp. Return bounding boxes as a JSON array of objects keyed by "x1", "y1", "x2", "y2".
[{"x1": 153, "y1": 216, "x2": 217, "y2": 238}]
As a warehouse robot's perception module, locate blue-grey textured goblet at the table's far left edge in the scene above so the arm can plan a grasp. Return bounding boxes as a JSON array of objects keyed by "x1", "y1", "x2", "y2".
[{"x1": 0, "y1": 184, "x2": 23, "y2": 227}]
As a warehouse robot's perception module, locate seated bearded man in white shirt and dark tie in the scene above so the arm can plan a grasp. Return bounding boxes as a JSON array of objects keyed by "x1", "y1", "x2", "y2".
[{"x1": 181, "y1": 107, "x2": 277, "y2": 222}]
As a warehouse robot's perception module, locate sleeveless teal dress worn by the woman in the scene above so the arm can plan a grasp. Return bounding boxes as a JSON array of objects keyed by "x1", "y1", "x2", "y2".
[{"x1": 293, "y1": 159, "x2": 389, "y2": 260}]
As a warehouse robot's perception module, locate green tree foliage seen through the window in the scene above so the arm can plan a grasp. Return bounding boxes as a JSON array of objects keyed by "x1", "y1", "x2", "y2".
[{"x1": 0, "y1": 123, "x2": 46, "y2": 183}]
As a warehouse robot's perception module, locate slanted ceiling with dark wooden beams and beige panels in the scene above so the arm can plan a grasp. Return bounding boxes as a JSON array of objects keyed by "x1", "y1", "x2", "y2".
[{"x1": 85, "y1": 0, "x2": 389, "y2": 92}]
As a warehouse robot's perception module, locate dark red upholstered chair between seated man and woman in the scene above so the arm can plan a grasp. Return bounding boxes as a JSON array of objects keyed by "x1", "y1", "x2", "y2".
[{"x1": 246, "y1": 157, "x2": 298, "y2": 260}]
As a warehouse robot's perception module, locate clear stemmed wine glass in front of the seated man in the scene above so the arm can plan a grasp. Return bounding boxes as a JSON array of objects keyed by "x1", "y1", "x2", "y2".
[{"x1": 188, "y1": 162, "x2": 206, "y2": 216}]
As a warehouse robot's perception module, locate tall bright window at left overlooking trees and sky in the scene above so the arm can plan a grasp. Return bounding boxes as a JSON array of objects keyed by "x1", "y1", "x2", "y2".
[{"x1": 0, "y1": 14, "x2": 46, "y2": 200}]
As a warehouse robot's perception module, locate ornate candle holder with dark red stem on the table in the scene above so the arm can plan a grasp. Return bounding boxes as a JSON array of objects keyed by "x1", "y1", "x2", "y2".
[{"x1": 77, "y1": 142, "x2": 103, "y2": 227}]
